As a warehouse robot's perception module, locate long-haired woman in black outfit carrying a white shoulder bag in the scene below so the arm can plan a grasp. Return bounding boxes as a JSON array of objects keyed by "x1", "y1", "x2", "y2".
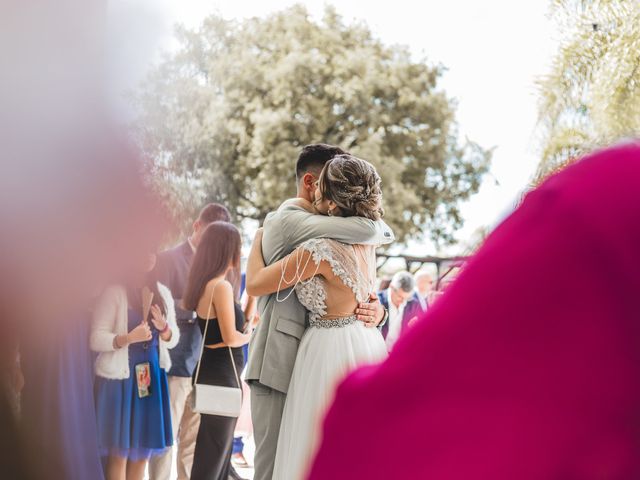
[{"x1": 183, "y1": 222, "x2": 251, "y2": 480}]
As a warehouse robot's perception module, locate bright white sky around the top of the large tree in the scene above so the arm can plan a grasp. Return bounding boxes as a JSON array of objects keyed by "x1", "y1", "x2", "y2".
[{"x1": 110, "y1": 0, "x2": 557, "y2": 254}]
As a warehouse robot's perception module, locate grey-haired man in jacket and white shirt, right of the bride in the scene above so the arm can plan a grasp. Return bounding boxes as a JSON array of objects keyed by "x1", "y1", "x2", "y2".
[{"x1": 378, "y1": 271, "x2": 415, "y2": 351}]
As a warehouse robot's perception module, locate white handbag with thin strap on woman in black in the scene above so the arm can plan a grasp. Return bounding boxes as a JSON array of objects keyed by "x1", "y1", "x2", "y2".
[{"x1": 191, "y1": 286, "x2": 242, "y2": 417}]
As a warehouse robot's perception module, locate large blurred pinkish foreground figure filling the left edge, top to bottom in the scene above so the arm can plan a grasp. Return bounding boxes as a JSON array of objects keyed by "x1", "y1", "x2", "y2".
[{"x1": 0, "y1": 0, "x2": 167, "y2": 480}]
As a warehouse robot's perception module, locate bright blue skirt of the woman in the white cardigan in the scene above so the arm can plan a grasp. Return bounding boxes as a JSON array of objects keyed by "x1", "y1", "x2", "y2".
[{"x1": 96, "y1": 337, "x2": 173, "y2": 461}]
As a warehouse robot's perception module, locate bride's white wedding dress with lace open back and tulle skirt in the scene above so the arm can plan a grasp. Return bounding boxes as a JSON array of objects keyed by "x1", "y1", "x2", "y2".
[{"x1": 272, "y1": 239, "x2": 387, "y2": 480}]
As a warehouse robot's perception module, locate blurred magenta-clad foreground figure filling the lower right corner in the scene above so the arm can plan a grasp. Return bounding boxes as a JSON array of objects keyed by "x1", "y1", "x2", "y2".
[{"x1": 309, "y1": 142, "x2": 640, "y2": 480}]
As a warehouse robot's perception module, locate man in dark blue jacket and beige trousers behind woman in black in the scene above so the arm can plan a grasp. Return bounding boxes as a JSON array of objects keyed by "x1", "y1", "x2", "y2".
[{"x1": 149, "y1": 203, "x2": 231, "y2": 480}]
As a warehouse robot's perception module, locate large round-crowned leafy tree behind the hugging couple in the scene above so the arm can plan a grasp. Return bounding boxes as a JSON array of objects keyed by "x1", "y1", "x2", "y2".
[{"x1": 137, "y1": 6, "x2": 490, "y2": 244}]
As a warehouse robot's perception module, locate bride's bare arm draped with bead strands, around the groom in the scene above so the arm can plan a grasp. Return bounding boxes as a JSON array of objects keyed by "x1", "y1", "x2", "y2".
[{"x1": 246, "y1": 229, "x2": 329, "y2": 297}]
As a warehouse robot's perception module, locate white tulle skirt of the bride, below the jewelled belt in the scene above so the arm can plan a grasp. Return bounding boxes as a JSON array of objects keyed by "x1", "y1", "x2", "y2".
[{"x1": 273, "y1": 321, "x2": 387, "y2": 480}]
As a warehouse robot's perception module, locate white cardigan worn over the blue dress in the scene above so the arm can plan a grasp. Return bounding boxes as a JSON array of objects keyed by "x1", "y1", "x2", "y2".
[{"x1": 89, "y1": 282, "x2": 180, "y2": 379}]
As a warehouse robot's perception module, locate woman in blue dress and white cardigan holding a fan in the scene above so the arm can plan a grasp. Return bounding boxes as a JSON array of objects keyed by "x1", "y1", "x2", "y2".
[{"x1": 91, "y1": 256, "x2": 179, "y2": 480}]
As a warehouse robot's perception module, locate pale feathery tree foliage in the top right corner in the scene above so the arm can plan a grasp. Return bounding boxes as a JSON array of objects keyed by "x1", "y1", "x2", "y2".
[{"x1": 538, "y1": 0, "x2": 640, "y2": 178}]
